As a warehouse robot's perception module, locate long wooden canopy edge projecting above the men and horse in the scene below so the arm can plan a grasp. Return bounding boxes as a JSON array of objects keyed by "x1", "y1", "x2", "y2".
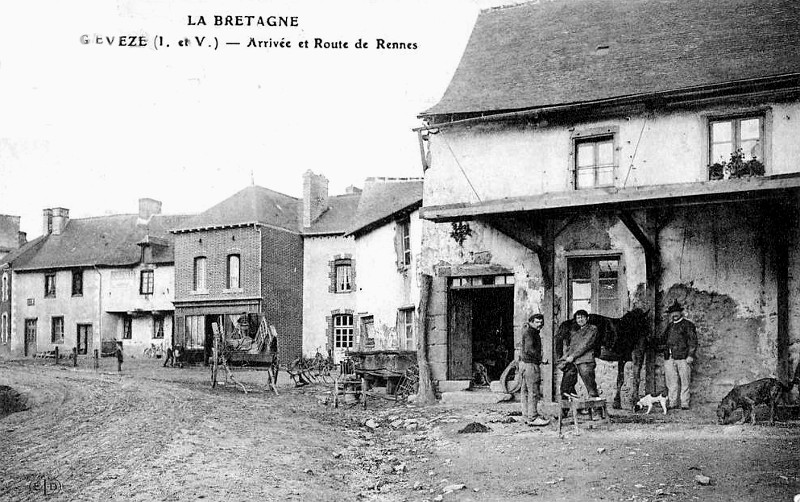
[{"x1": 420, "y1": 173, "x2": 800, "y2": 222}]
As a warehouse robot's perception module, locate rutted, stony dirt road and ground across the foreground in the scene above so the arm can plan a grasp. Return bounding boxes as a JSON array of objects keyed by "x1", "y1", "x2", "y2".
[{"x1": 0, "y1": 359, "x2": 800, "y2": 502}]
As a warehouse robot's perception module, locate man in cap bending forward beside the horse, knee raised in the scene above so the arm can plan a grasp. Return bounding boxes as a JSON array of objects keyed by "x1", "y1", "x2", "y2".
[{"x1": 558, "y1": 310, "x2": 599, "y2": 398}]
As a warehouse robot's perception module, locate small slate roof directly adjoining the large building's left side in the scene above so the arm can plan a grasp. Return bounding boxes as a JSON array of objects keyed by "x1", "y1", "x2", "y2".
[{"x1": 348, "y1": 179, "x2": 422, "y2": 236}]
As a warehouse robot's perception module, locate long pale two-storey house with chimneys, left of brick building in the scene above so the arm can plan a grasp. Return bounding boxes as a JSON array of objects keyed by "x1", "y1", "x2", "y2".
[{"x1": 10, "y1": 199, "x2": 185, "y2": 356}]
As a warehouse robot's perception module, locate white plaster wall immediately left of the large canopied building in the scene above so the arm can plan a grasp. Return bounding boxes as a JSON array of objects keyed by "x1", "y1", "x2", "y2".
[{"x1": 356, "y1": 211, "x2": 422, "y2": 350}]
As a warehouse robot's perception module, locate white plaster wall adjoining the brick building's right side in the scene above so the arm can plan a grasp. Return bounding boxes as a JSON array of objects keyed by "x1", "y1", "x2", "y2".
[{"x1": 303, "y1": 236, "x2": 354, "y2": 357}]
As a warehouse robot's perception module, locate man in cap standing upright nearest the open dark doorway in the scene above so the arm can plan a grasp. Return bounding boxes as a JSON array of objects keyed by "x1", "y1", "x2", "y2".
[{"x1": 519, "y1": 314, "x2": 550, "y2": 427}]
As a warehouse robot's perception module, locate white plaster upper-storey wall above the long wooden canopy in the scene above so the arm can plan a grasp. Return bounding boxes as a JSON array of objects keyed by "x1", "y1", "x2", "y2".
[{"x1": 425, "y1": 103, "x2": 800, "y2": 206}]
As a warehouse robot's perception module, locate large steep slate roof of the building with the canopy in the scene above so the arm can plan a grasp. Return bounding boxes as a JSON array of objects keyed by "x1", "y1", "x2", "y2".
[{"x1": 421, "y1": 0, "x2": 800, "y2": 116}]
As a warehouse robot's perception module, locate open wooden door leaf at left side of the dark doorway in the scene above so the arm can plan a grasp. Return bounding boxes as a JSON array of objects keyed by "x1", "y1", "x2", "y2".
[{"x1": 448, "y1": 291, "x2": 472, "y2": 380}]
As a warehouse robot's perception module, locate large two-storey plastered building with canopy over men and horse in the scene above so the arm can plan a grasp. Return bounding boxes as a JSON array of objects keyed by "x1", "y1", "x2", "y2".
[{"x1": 419, "y1": 0, "x2": 800, "y2": 403}]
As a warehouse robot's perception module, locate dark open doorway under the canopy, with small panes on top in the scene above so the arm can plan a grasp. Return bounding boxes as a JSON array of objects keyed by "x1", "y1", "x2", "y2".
[{"x1": 448, "y1": 276, "x2": 514, "y2": 381}]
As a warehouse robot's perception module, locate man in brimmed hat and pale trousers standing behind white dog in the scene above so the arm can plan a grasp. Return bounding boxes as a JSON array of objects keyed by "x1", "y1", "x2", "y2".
[{"x1": 661, "y1": 300, "x2": 697, "y2": 410}]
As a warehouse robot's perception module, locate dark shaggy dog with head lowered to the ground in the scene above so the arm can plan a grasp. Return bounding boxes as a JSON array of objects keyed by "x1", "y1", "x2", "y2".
[{"x1": 717, "y1": 378, "x2": 797, "y2": 425}]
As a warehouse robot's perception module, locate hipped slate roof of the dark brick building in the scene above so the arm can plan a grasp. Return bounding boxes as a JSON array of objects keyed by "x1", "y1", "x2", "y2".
[{"x1": 176, "y1": 185, "x2": 302, "y2": 232}]
